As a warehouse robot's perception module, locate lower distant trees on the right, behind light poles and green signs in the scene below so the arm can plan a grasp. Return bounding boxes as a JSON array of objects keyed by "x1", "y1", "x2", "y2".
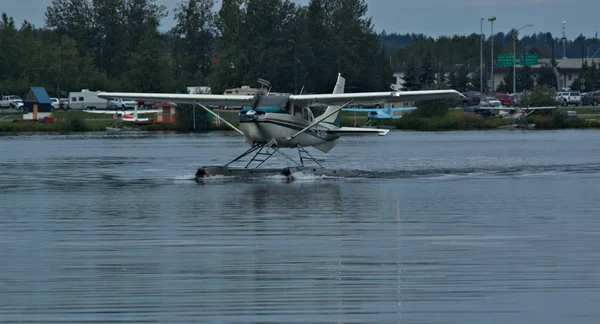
[{"x1": 394, "y1": 29, "x2": 600, "y2": 93}]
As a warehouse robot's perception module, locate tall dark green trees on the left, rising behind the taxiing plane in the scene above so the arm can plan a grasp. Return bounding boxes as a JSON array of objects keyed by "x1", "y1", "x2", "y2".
[{"x1": 0, "y1": 0, "x2": 391, "y2": 96}]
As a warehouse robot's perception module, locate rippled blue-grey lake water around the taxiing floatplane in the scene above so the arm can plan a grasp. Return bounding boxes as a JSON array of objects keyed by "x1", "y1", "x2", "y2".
[{"x1": 0, "y1": 131, "x2": 600, "y2": 323}]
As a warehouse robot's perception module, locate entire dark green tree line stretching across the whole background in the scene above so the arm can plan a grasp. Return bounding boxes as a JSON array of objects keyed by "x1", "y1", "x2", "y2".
[{"x1": 0, "y1": 0, "x2": 600, "y2": 97}]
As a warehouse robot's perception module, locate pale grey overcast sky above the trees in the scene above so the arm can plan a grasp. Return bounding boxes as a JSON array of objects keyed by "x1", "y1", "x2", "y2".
[{"x1": 0, "y1": 0, "x2": 600, "y2": 39}]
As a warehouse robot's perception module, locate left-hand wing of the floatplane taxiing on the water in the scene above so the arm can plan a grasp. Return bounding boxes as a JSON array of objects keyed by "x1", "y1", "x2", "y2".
[{"x1": 98, "y1": 92, "x2": 254, "y2": 107}]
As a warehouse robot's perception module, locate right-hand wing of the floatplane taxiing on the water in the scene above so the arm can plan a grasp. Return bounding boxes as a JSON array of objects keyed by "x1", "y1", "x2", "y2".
[{"x1": 290, "y1": 90, "x2": 463, "y2": 105}]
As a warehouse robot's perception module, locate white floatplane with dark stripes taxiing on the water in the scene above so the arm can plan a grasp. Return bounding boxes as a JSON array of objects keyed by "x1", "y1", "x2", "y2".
[{"x1": 98, "y1": 75, "x2": 461, "y2": 177}]
